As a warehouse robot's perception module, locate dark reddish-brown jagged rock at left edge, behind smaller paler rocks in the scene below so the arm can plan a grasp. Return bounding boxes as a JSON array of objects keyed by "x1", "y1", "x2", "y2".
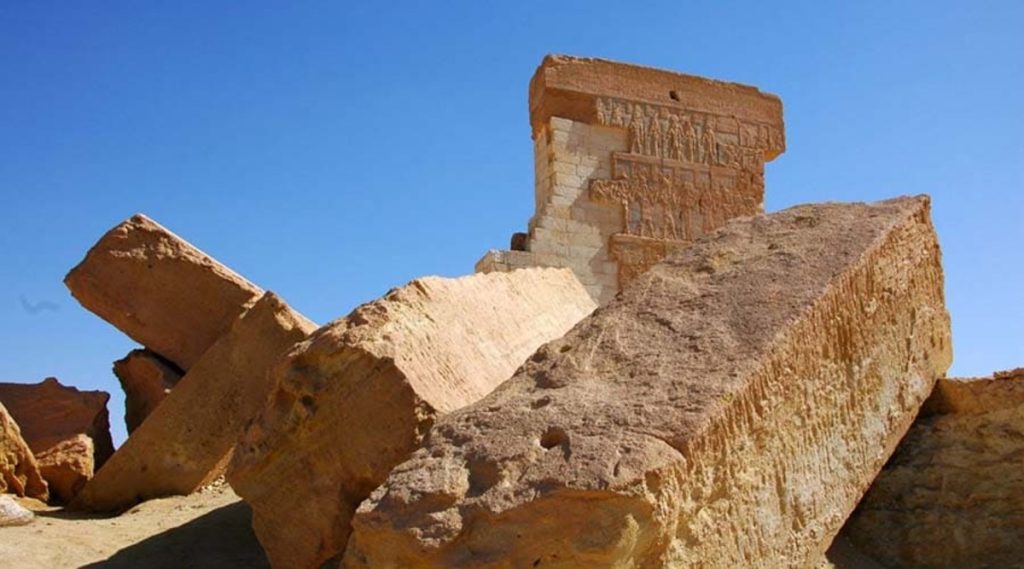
[{"x1": 0, "y1": 378, "x2": 114, "y2": 468}]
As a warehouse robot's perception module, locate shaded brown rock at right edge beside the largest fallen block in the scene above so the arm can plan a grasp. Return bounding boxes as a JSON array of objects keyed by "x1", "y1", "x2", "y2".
[{"x1": 841, "y1": 368, "x2": 1024, "y2": 569}]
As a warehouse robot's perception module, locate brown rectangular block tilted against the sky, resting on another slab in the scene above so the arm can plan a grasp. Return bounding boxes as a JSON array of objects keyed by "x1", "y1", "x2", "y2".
[{"x1": 65, "y1": 214, "x2": 262, "y2": 369}]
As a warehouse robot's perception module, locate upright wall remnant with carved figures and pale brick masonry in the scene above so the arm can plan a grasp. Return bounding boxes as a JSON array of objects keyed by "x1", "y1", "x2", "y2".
[{"x1": 476, "y1": 56, "x2": 784, "y2": 303}]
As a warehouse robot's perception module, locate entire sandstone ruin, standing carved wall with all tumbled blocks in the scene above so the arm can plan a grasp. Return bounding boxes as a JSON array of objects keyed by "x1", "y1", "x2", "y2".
[{"x1": 0, "y1": 56, "x2": 1024, "y2": 569}]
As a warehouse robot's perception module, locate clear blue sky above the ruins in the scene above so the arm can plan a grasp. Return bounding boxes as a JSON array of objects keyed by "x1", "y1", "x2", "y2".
[{"x1": 0, "y1": 0, "x2": 1024, "y2": 440}]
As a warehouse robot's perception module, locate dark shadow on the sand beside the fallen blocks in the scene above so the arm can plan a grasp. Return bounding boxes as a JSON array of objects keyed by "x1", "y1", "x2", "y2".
[{"x1": 82, "y1": 501, "x2": 270, "y2": 569}]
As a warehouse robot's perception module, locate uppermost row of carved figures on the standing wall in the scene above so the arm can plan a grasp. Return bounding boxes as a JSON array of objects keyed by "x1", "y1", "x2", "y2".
[{"x1": 596, "y1": 98, "x2": 782, "y2": 167}]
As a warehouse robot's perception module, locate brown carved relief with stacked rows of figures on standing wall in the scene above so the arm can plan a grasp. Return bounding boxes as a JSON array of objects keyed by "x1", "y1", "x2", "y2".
[{"x1": 590, "y1": 98, "x2": 781, "y2": 287}]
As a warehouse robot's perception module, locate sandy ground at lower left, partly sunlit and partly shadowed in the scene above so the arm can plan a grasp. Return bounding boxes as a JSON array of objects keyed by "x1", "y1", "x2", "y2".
[{"x1": 0, "y1": 485, "x2": 269, "y2": 569}]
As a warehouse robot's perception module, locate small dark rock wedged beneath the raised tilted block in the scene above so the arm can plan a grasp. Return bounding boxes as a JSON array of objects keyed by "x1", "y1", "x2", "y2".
[{"x1": 114, "y1": 350, "x2": 184, "y2": 434}]
